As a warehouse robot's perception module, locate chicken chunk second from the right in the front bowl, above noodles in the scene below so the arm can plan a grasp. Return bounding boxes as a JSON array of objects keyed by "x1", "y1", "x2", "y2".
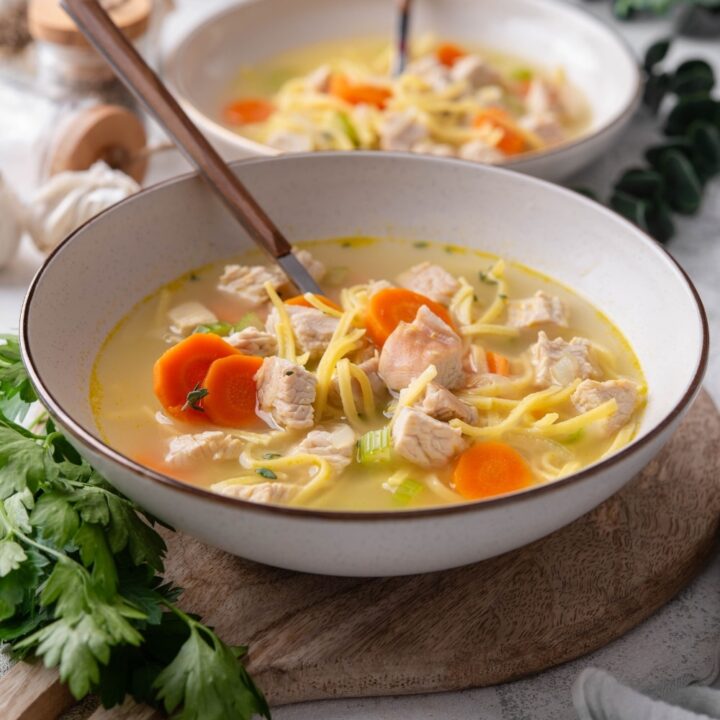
[{"x1": 530, "y1": 330, "x2": 597, "y2": 387}]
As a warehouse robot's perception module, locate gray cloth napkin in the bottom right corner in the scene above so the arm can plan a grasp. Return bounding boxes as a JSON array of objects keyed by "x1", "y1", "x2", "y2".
[{"x1": 572, "y1": 668, "x2": 720, "y2": 720}]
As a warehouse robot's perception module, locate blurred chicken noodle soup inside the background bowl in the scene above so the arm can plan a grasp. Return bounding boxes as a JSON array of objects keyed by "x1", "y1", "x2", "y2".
[{"x1": 221, "y1": 37, "x2": 589, "y2": 163}]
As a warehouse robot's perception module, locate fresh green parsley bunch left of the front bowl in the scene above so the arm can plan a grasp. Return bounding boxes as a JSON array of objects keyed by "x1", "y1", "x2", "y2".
[{"x1": 0, "y1": 335, "x2": 270, "y2": 720}]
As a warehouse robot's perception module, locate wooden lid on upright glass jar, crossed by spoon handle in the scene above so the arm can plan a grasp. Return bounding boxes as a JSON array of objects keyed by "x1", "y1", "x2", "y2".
[{"x1": 28, "y1": 0, "x2": 152, "y2": 47}]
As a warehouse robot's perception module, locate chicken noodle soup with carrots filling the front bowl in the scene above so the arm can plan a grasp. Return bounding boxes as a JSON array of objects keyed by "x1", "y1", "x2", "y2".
[{"x1": 91, "y1": 238, "x2": 645, "y2": 510}]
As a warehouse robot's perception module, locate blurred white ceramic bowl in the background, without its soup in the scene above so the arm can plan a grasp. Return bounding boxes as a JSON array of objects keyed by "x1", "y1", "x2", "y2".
[{"x1": 164, "y1": 0, "x2": 641, "y2": 180}]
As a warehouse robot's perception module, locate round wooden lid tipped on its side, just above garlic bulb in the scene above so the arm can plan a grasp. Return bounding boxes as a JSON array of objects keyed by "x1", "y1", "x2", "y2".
[{"x1": 48, "y1": 105, "x2": 147, "y2": 182}]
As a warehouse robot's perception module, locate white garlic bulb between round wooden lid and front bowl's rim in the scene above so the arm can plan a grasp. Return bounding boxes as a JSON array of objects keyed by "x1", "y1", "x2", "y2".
[{"x1": 27, "y1": 161, "x2": 140, "y2": 252}]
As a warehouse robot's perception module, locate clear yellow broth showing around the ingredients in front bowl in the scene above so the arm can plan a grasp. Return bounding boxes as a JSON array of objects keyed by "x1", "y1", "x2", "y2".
[{"x1": 90, "y1": 238, "x2": 643, "y2": 510}]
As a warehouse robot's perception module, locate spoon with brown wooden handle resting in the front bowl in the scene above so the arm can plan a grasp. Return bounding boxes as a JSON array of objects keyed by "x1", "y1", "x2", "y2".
[{"x1": 60, "y1": 0, "x2": 320, "y2": 294}]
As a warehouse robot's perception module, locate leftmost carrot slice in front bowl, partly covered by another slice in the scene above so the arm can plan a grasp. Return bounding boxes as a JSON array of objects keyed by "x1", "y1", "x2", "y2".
[{"x1": 153, "y1": 333, "x2": 239, "y2": 421}]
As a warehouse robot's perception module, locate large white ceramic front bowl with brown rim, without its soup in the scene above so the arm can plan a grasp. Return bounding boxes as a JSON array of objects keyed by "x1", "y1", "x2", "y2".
[{"x1": 21, "y1": 153, "x2": 708, "y2": 576}]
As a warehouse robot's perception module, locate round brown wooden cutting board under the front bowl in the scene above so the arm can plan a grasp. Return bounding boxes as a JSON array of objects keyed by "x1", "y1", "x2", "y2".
[{"x1": 0, "y1": 393, "x2": 720, "y2": 720}]
